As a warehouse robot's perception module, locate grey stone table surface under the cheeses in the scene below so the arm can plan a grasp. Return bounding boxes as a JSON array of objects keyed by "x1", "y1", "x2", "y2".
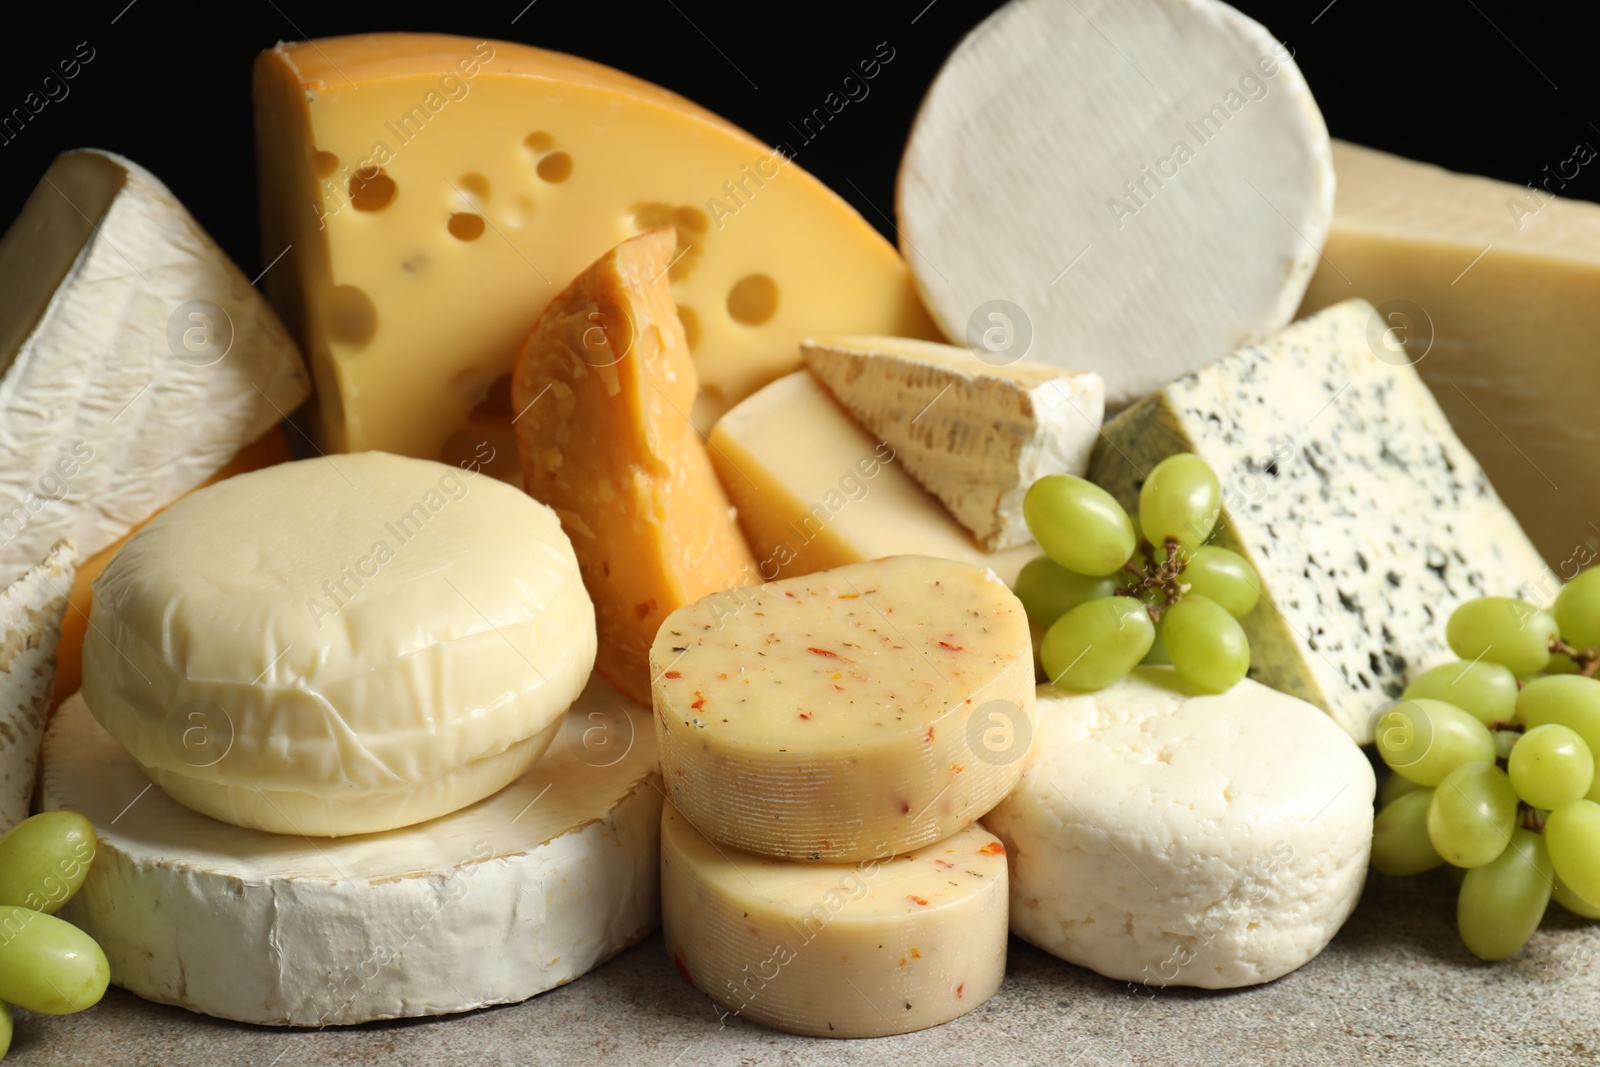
[{"x1": 5, "y1": 873, "x2": 1600, "y2": 1067}]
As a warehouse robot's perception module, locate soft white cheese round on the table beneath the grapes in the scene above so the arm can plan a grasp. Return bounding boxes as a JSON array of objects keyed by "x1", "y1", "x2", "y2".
[{"x1": 984, "y1": 667, "x2": 1376, "y2": 989}]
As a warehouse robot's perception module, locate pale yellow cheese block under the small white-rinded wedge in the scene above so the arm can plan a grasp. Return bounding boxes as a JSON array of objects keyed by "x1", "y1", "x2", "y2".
[{"x1": 710, "y1": 371, "x2": 1038, "y2": 582}]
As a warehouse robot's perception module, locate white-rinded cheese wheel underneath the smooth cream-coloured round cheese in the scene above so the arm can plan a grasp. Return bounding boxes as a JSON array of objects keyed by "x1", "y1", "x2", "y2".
[{"x1": 40, "y1": 680, "x2": 661, "y2": 1027}]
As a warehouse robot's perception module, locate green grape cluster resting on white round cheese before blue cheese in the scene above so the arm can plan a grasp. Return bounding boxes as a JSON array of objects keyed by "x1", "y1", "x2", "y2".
[{"x1": 1016, "y1": 453, "x2": 1261, "y2": 693}]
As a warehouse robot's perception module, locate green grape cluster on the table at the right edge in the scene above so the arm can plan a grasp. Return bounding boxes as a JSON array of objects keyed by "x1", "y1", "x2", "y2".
[{"x1": 1373, "y1": 568, "x2": 1600, "y2": 960}]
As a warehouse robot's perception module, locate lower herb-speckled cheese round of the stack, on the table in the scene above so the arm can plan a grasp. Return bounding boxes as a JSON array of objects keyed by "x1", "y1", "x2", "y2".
[{"x1": 661, "y1": 805, "x2": 1006, "y2": 1038}]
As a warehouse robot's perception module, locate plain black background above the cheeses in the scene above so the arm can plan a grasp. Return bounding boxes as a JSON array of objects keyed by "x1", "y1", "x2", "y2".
[{"x1": 0, "y1": 0, "x2": 1600, "y2": 272}]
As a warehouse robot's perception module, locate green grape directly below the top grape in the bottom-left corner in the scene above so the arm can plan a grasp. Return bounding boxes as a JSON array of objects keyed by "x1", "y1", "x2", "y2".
[{"x1": 0, "y1": 905, "x2": 110, "y2": 1016}]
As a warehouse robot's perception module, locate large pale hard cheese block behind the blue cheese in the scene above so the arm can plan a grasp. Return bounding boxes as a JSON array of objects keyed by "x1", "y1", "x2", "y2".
[{"x1": 1302, "y1": 141, "x2": 1600, "y2": 566}]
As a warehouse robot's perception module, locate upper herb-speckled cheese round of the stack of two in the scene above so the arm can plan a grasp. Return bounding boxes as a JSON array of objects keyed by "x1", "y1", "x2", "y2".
[{"x1": 650, "y1": 555, "x2": 1034, "y2": 862}]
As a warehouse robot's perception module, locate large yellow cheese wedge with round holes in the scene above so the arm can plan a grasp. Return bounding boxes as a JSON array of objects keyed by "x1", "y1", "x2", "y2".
[{"x1": 254, "y1": 34, "x2": 934, "y2": 459}]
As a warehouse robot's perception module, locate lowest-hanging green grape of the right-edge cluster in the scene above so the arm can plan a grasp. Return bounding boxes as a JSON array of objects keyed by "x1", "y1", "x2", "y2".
[{"x1": 1456, "y1": 829, "x2": 1555, "y2": 960}]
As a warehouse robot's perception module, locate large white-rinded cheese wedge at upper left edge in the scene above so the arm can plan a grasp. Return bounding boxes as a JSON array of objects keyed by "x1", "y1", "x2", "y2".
[{"x1": 0, "y1": 149, "x2": 310, "y2": 584}]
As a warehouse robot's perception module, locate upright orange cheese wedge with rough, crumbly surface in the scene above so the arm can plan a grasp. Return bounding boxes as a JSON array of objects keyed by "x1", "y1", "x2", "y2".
[{"x1": 512, "y1": 229, "x2": 760, "y2": 702}]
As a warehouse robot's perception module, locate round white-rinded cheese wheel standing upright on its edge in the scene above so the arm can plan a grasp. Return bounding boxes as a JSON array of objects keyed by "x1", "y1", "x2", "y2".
[{"x1": 896, "y1": 0, "x2": 1334, "y2": 406}]
